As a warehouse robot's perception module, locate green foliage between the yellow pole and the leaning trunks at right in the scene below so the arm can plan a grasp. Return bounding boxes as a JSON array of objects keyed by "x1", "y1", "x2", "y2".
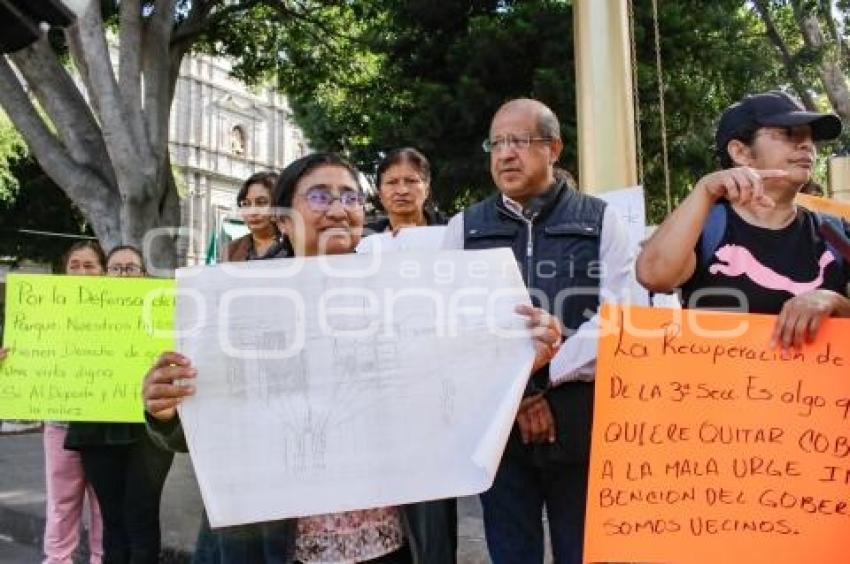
[{"x1": 634, "y1": 0, "x2": 787, "y2": 221}]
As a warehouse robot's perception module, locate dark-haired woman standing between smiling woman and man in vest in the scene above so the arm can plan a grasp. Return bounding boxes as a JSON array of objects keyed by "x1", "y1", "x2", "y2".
[{"x1": 366, "y1": 147, "x2": 446, "y2": 233}]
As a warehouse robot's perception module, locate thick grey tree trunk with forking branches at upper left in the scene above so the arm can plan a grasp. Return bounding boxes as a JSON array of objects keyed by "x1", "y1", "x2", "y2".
[{"x1": 0, "y1": 0, "x2": 185, "y2": 275}]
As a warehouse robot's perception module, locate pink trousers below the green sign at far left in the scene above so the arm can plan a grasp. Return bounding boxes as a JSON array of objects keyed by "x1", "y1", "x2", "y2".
[{"x1": 44, "y1": 423, "x2": 103, "y2": 564}]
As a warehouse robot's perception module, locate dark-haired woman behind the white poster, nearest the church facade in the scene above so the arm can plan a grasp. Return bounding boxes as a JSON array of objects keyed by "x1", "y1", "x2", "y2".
[{"x1": 224, "y1": 172, "x2": 287, "y2": 262}]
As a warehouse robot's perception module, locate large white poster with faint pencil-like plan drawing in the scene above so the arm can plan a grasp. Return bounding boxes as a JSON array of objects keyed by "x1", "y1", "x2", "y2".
[{"x1": 176, "y1": 249, "x2": 534, "y2": 527}]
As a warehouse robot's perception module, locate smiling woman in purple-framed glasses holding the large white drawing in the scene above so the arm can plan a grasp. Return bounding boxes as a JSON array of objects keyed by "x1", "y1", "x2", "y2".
[{"x1": 143, "y1": 153, "x2": 560, "y2": 564}]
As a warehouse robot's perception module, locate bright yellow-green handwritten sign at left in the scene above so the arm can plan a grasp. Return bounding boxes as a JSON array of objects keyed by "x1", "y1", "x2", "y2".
[{"x1": 0, "y1": 274, "x2": 175, "y2": 422}]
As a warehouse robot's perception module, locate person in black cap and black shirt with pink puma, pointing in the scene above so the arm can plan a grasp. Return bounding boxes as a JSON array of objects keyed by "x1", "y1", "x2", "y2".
[{"x1": 637, "y1": 91, "x2": 850, "y2": 349}]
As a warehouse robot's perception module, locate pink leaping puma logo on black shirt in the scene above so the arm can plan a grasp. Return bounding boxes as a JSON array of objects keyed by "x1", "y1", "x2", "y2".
[{"x1": 708, "y1": 245, "x2": 835, "y2": 296}]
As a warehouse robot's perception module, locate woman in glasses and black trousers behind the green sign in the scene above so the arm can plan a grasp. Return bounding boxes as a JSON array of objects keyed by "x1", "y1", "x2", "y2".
[{"x1": 65, "y1": 245, "x2": 174, "y2": 564}]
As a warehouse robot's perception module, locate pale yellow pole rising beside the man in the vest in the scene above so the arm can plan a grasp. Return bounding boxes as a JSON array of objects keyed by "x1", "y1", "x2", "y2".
[{"x1": 573, "y1": 0, "x2": 637, "y2": 193}]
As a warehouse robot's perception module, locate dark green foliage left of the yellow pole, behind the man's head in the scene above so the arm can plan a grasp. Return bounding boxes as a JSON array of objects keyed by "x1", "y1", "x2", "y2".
[{"x1": 216, "y1": 0, "x2": 576, "y2": 209}]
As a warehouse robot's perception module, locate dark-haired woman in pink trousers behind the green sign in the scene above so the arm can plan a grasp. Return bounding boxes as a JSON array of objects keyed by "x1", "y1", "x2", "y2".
[{"x1": 44, "y1": 241, "x2": 106, "y2": 564}]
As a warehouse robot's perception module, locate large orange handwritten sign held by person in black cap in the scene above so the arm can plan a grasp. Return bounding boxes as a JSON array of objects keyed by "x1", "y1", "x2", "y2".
[{"x1": 585, "y1": 306, "x2": 850, "y2": 564}]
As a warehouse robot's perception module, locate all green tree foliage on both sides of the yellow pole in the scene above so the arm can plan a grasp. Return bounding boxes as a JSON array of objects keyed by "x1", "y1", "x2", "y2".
[{"x1": 218, "y1": 0, "x2": 847, "y2": 221}]
